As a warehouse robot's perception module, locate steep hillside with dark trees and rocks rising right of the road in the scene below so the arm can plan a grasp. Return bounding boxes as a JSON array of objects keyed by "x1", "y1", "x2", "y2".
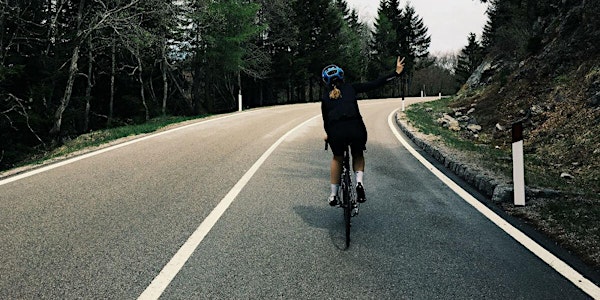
[{"x1": 452, "y1": 0, "x2": 600, "y2": 198}]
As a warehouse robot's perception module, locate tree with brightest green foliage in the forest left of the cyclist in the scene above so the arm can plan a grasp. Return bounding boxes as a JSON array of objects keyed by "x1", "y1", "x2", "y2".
[{"x1": 190, "y1": 0, "x2": 263, "y2": 112}]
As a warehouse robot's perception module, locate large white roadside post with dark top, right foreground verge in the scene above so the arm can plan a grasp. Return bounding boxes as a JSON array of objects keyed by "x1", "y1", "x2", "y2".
[{"x1": 512, "y1": 122, "x2": 525, "y2": 206}]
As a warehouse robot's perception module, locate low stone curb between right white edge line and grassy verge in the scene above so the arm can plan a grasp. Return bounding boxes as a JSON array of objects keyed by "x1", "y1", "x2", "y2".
[{"x1": 395, "y1": 113, "x2": 561, "y2": 203}]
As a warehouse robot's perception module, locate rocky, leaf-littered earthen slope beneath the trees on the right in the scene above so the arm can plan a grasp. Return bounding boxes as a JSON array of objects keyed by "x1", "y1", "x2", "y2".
[{"x1": 452, "y1": 0, "x2": 600, "y2": 196}]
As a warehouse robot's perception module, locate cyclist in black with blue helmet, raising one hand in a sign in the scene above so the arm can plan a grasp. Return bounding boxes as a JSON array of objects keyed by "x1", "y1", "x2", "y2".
[{"x1": 321, "y1": 57, "x2": 404, "y2": 206}]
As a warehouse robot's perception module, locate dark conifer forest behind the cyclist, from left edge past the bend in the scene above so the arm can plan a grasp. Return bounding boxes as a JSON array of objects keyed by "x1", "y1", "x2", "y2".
[{"x1": 0, "y1": 0, "x2": 481, "y2": 170}]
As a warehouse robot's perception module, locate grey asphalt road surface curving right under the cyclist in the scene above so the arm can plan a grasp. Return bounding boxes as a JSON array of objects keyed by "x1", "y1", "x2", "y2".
[{"x1": 0, "y1": 99, "x2": 589, "y2": 299}]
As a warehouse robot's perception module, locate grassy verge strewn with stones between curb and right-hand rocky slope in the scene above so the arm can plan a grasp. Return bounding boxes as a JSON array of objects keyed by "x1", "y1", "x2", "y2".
[{"x1": 406, "y1": 98, "x2": 600, "y2": 269}]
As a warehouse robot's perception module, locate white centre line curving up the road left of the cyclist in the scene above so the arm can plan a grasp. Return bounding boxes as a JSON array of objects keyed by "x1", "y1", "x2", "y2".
[{"x1": 138, "y1": 115, "x2": 320, "y2": 300}]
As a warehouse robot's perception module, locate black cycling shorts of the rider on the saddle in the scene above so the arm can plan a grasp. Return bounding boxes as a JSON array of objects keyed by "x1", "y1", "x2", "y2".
[{"x1": 327, "y1": 119, "x2": 367, "y2": 156}]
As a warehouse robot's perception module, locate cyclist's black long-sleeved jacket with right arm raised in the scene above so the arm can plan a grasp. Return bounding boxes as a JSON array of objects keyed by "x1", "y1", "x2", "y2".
[{"x1": 321, "y1": 72, "x2": 398, "y2": 133}]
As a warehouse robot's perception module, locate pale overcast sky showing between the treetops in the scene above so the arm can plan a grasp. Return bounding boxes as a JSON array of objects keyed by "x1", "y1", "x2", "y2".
[{"x1": 346, "y1": 0, "x2": 488, "y2": 54}]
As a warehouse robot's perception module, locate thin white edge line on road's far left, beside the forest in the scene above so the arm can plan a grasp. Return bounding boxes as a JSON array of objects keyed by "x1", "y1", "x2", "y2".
[{"x1": 0, "y1": 111, "x2": 262, "y2": 186}]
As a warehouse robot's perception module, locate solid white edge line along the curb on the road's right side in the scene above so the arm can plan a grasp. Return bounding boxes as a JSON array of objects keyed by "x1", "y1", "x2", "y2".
[{"x1": 388, "y1": 109, "x2": 600, "y2": 299}]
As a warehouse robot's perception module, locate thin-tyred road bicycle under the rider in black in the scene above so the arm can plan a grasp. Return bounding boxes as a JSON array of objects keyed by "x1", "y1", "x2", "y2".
[{"x1": 325, "y1": 142, "x2": 359, "y2": 248}]
